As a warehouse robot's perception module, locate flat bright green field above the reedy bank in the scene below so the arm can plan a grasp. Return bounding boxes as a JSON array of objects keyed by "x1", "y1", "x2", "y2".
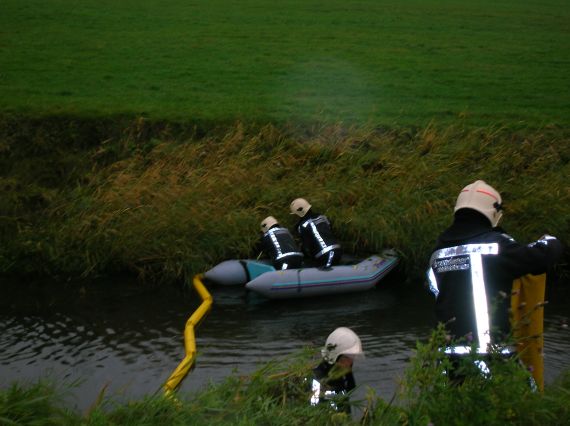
[{"x1": 0, "y1": 0, "x2": 570, "y2": 128}]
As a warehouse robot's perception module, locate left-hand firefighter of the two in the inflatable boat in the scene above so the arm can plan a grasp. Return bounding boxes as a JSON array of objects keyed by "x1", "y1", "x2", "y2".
[{"x1": 261, "y1": 216, "x2": 303, "y2": 270}]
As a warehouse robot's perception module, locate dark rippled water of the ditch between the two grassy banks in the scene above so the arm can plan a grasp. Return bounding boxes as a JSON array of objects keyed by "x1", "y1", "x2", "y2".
[{"x1": 0, "y1": 274, "x2": 570, "y2": 410}]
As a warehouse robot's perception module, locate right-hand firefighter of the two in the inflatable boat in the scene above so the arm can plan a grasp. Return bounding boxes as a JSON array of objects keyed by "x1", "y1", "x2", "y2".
[{"x1": 290, "y1": 198, "x2": 342, "y2": 268}]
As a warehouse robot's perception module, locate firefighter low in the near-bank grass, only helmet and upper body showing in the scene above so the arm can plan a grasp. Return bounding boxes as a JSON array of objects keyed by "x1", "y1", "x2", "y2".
[{"x1": 311, "y1": 327, "x2": 363, "y2": 413}]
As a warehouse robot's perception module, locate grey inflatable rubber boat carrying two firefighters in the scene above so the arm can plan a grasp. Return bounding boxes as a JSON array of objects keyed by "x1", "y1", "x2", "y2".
[{"x1": 204, "y1": 250, "x2": 399, "y2": 299}]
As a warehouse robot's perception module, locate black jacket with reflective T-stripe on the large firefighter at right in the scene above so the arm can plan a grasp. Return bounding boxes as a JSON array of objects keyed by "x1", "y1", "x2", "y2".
[{"x1": 428, "y1": 209, "x2": 563, "y2": 343}]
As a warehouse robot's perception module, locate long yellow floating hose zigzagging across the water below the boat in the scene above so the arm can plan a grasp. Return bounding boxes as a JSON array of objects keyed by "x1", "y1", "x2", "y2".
[{"x1": 164, "y1": 274, "x2": 214, "y2": 396}]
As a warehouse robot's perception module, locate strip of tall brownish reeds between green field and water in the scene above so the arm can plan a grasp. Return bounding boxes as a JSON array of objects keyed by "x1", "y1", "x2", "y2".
[{"x1": 0, "y1": 120, "x2": 570, "y2": 281}]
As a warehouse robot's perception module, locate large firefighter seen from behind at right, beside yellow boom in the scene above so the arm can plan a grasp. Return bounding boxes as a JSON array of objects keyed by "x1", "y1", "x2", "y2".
[{"x1": 428, "y1": 180, "x2": 563, "y2": 362}]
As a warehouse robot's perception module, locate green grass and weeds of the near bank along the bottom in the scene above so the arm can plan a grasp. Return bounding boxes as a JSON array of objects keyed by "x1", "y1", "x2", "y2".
[{"x1": 0, "y1": 330, "x2": 570, "y2": 426}]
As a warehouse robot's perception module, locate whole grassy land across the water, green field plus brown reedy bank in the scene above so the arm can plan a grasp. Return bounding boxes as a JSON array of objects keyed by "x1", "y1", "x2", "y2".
[{"x1": 0, "y1": 0, "x2": 570, "y2": 280}]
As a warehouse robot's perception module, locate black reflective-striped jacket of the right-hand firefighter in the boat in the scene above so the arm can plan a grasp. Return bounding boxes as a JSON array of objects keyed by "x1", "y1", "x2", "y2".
[{"x1": 295, "y1": 209, "x2": 340, "y2": 259}]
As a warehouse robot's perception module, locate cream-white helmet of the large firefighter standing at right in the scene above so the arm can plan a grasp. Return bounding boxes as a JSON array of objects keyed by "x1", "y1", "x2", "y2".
[{"x1": 454, "y1": 180, "x2": 503, "y2": 226}]
